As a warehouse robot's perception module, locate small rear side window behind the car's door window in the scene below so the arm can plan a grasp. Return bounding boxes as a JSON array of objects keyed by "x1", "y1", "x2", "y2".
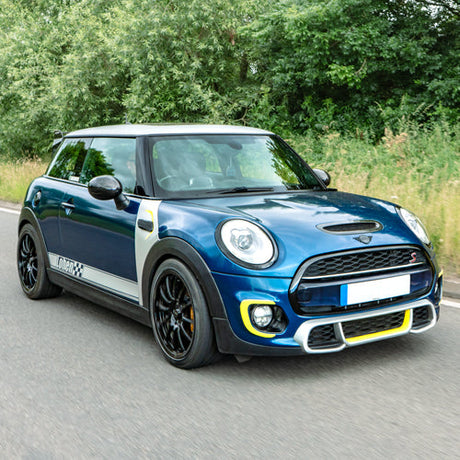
[{"x1": 48, "y1": 139, "x2": 90, "y2": 182}]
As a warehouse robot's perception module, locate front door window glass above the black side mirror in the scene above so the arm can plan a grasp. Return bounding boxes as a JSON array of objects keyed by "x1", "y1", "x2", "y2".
[{"x1": 80, "y1": 137, "x2": 136, "y2": 193}]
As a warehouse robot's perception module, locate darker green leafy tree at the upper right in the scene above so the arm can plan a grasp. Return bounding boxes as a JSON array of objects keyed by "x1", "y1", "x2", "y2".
[{"x1": 245, "y1": 0, "x2": 460, "y2": 136}]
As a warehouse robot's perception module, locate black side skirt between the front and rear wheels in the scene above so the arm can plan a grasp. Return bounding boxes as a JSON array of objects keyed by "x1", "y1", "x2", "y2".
[{"x1": 47, "y1": 268, "x2": 152, "y2": 327}]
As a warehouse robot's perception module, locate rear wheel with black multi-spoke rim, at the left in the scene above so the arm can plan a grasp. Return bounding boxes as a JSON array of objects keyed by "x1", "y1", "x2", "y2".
[{"x1": 17, "y1": 224, "x2": 62, "y2": 299}]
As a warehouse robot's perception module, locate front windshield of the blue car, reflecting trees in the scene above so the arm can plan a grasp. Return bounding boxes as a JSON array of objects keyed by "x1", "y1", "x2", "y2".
[{"x1": 149, "y1": 135, "x2": 323, "y2": 197}]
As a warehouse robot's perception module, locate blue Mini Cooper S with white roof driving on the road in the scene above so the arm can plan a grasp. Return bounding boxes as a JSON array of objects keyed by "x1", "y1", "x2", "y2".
[{"x1": 17, "y1": 124, "x2": 442, "y2": 368}]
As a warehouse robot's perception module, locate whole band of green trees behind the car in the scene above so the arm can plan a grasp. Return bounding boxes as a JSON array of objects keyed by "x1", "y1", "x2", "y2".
[{"x1": 0, "y1": 0, "x2": 460, "y2": 157}]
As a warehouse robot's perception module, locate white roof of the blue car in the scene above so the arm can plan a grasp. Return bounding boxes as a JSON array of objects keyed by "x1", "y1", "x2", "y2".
[{"x1": 65, "y1": 123, "x2": 272, "y2": 137}]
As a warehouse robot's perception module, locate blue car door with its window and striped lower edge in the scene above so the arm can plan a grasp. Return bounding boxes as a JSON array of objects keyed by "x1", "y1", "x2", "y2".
[{"x1": 57, "y1": 138, "x2": 140, "y2": 301}]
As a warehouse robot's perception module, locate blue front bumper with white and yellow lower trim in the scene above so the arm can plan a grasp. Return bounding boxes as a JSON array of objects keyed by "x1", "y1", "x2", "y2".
[{"x1": 213, "y1": 273, "x2": 442, "y2": 356}]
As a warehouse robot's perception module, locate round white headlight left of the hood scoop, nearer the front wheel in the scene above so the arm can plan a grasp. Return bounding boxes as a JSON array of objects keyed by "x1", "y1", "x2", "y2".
[{"x1": 216, "y1": 219, "x2": 278, "y2": 268}]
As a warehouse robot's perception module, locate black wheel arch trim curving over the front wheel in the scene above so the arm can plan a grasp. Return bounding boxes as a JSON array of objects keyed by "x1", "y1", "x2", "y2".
[{"x1": 142, "y1": 237, "x2": 227, "y2": 319}]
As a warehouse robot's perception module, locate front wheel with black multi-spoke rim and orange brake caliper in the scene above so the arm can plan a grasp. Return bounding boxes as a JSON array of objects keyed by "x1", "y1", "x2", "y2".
[{"x1": 150, "y1": 259, "x2": 218, "y2": 369}]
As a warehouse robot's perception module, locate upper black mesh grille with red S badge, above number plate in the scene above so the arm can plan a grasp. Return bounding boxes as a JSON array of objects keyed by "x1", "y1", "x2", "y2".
[{"x1": 303, "y1": 247, "x2": 427, "y2": 278}]
